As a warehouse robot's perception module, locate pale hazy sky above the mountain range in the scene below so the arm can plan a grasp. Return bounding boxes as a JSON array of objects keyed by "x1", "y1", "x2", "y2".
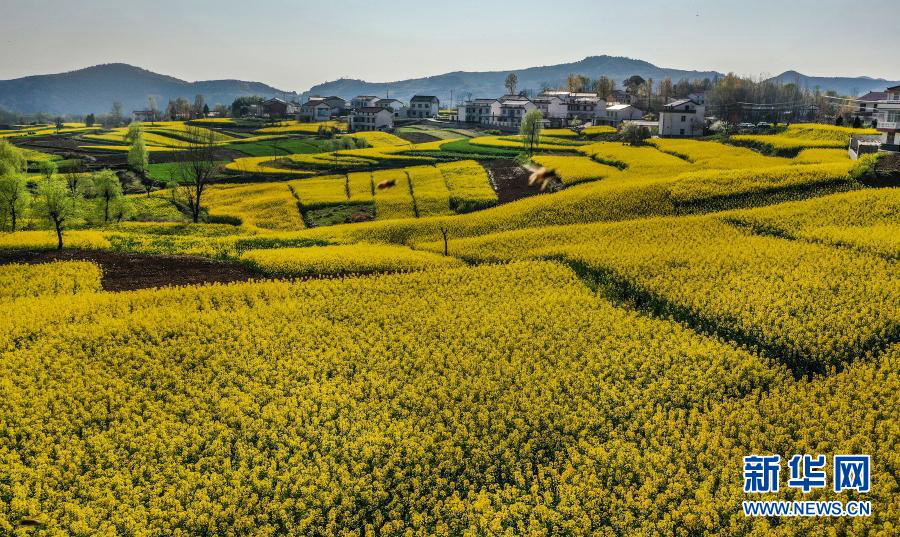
[{"x1": 0, "y1": 0, "x2": 900, "y2": 91}]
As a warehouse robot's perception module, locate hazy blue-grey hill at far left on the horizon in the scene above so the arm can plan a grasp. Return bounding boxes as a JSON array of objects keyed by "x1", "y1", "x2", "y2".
[{"x1": 0, "y1": 63, "x2": 299, "y2": 115}]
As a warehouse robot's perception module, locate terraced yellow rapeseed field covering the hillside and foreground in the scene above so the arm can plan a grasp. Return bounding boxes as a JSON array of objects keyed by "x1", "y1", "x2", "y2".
[{"x1": 0, "y1": 122, "x2": 900, "y2": 536}]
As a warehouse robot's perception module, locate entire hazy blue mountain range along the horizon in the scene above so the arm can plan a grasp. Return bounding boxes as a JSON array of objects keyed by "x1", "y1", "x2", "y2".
[{"x1": 0, "y1": 56, "x2": 900, "y2": 115}]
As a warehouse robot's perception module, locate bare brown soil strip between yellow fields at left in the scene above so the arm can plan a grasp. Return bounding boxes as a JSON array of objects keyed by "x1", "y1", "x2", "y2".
[{"x1": 0, "y1": 250, "x2": 259, "y2": 291}]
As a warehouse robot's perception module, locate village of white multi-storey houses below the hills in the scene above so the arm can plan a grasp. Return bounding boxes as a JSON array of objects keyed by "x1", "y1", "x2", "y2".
[{"x1": 185, "y1": 77, "x2": 900, "y2": 159}]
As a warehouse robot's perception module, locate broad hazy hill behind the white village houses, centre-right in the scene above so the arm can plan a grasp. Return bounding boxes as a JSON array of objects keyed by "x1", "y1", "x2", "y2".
[{"x1": 304, "y1": 56, "x2": 723, "y2": 101}]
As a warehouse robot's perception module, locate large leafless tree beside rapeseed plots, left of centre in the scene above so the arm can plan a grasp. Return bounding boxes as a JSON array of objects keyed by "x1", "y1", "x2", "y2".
[{"x1": 176, "y1": 127, "x2": 221, "y2": 223}]
